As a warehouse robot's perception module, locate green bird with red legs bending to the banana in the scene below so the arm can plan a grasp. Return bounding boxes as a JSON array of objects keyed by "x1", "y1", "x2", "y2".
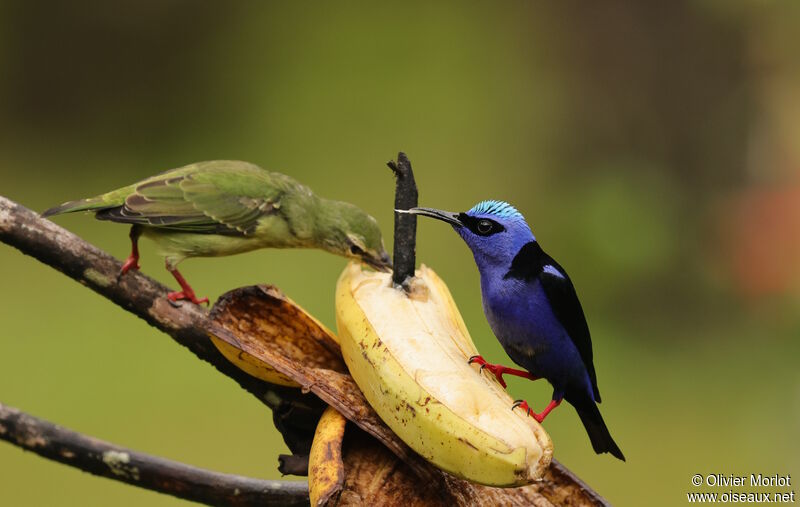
[{"x1": 42, "y1": 160, "x2": 392, "y2": 304}]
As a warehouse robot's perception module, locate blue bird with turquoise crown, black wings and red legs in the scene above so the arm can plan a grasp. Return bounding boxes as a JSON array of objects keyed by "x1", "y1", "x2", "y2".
[{"x1": 406, "y1": 201, "x2": 625, "y2": 461}]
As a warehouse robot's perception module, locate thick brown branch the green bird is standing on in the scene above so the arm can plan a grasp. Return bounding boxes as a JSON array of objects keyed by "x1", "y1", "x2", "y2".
[{"x1": 0, "y1": 196, "x2": 326, "y2": 462}]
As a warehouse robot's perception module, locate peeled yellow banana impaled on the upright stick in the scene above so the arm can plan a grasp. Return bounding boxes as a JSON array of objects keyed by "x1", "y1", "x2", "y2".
[{"x1": 336, "y1": 263, "x2": 553, "y2": 487}]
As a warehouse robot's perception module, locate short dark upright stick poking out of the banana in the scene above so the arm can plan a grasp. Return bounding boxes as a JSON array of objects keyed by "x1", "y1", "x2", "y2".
[{"x1": 386, "y1": 151, "x2": 419, "y2": 287}]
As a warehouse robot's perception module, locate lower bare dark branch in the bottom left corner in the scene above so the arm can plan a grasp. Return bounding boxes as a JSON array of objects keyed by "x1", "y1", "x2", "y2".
[{"x1": 0, "y1": 403, "x2": 309, "y2": 506}]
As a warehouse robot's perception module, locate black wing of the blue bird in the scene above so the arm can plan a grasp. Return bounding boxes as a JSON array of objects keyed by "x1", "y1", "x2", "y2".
[{"x1": 504, "y1": 241, "x2": 600, "y2": 403}]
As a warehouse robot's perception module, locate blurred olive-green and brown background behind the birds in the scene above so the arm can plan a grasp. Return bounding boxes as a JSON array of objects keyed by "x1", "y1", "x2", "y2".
[{"x1": 0, "y1": 0, "x2": 800, "y2": 506}]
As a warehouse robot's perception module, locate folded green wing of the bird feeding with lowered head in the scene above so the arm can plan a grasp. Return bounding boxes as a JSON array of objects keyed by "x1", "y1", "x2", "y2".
[{"x1": 97, "y1": 161, "x2": 296, "y2": 236}]
